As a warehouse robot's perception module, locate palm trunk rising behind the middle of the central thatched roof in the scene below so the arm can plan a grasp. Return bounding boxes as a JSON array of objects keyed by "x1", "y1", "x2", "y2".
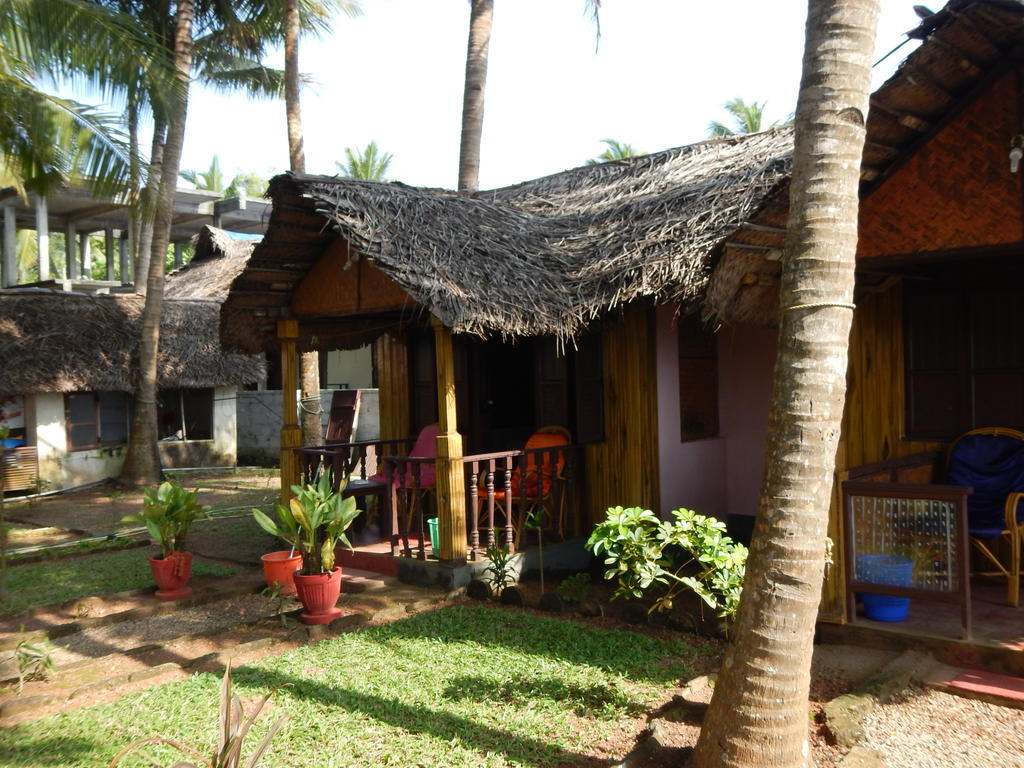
[{"x1": 459, "y1": 0, "x2": 495, "y2": 195}]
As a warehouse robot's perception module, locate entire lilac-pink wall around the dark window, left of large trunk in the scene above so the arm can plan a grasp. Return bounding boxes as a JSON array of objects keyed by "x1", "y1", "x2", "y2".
[{"x1": 656, "y1": 306, "x2": 777, "y2": 519}]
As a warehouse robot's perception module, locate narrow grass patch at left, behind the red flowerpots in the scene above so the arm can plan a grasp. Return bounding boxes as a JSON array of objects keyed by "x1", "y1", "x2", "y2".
[{"x1": 0, "y1": 548, "x2": 234, "y2": 613}]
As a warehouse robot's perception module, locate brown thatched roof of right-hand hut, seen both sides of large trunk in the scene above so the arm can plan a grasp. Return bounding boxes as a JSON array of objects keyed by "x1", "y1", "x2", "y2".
[{"x1": 703, "y1": 0, "x2": 1024, "y2": 324}]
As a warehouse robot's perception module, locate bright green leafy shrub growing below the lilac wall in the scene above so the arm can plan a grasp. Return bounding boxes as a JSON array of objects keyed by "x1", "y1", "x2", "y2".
[{"x1": 587, "y1": 507, "x2": 746, "y2": 620}]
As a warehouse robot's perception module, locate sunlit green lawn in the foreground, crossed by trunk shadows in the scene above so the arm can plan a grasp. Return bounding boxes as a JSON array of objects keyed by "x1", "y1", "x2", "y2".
[{"x1": 0, "y1": 605, "x2": 710, "y2": 768}]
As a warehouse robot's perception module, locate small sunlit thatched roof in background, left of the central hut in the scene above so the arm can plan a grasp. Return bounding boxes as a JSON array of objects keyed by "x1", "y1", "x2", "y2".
[{"x1": 164, "y1": 225, "x2": 258, "y2": 299}]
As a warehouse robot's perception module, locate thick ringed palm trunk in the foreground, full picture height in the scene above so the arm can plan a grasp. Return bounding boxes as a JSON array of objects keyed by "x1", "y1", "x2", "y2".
[{"x1": 693, "y1": 0, "x2": 879, "y2": 768}]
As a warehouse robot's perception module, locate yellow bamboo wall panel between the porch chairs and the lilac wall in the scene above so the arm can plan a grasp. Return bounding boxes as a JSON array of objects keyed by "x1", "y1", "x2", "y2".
[{"x1": 584, "y1": 306, "x2": 660, "y2": 532}]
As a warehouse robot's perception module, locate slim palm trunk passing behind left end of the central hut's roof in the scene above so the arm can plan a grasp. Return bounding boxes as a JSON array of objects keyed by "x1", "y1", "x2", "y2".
[{"x1": 285, "y1": 0, "x2": 324, "y2": 445}]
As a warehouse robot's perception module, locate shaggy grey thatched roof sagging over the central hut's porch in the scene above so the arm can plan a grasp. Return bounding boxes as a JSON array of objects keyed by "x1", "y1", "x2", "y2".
[{"x1": 224, "y1": 128, "x2": 792, "y2": 349}]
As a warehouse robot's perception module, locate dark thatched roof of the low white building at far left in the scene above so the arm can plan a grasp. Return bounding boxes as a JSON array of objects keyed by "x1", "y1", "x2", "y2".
[{"x1": 0, "y1": 288, "x2": 265, "y2": 394}]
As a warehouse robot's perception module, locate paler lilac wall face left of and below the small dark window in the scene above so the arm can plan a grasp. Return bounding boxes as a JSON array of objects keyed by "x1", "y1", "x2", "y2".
[{"x1": 655, "y1": 306, "x2": 727, "y2": 519}]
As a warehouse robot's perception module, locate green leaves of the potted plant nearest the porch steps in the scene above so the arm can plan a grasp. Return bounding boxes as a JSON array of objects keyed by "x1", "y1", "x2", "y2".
[{"x1": 253, "y1": 473, "x2": 359, "y2": 575}]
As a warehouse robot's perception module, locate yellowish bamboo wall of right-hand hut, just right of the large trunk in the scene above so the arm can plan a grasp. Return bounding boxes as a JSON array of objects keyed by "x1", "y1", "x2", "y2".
[{"x1": 820, "y1": 284, "x2": 942, "y2": 621}]
